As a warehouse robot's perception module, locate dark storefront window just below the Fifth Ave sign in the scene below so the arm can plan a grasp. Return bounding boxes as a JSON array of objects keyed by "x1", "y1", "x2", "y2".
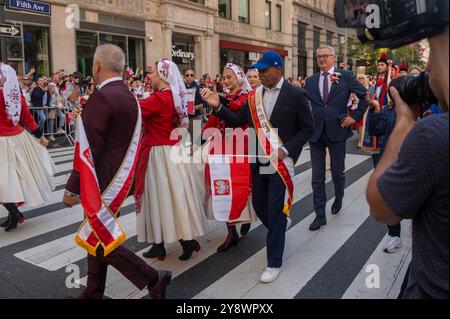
[{"x1": 23, "y1": 25, "x2": 51, "y2": 80}]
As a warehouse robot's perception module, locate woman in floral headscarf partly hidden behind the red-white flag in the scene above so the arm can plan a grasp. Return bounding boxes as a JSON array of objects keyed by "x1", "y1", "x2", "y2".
[{"x1": 203, "y1": 63, "x2": 256, "y2": 253}]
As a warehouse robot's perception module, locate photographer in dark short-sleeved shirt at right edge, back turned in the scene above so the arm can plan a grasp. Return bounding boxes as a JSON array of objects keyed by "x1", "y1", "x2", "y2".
[{"x1": 367, "y1": 25, "x2": 449, "y2": 299}]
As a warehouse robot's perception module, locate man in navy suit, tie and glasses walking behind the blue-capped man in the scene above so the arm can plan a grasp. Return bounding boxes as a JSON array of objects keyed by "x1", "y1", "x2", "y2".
[{"x1": 305, "y1": 46, "x2": 368, "y2": 231}]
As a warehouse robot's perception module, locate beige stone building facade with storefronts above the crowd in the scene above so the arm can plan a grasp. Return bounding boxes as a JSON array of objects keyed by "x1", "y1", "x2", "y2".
[{"x1": 0, "y1": 0, "x2": 352, "y2": 77}]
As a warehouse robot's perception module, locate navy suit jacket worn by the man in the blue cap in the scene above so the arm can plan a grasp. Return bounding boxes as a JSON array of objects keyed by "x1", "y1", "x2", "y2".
[{"x1": 215, "y1": 80, "x2": 314, "y2": 168}]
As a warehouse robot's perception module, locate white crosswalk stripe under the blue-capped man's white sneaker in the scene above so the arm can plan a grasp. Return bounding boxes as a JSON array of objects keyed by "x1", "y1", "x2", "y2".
[{"x1": 194, "y1": 174, "x2": 370, "y2": 299}]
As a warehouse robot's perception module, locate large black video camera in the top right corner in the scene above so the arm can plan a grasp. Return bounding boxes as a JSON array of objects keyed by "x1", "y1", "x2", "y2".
[{"x1": 334, "y1": 0, "x2": 449, "y2": 49}]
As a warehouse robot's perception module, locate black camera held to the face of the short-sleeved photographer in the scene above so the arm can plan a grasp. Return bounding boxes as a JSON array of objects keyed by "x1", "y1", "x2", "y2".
[{"x1": 390, "y1": 72, "x2": 438, "y2": 109}]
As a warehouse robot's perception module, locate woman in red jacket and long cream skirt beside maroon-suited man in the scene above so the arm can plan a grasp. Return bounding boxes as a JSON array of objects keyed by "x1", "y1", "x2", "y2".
[{"x1": 135, "y1": 60, "x2": 207, "y2": 260}]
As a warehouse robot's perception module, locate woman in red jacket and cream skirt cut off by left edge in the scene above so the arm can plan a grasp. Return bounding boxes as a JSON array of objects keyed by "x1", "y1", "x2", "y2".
[{"x1": 0, "y1": 63, "x2": 55, "y2": 231}]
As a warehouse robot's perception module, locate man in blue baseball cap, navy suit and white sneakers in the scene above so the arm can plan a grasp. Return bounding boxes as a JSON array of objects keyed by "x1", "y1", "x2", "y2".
[{"x1": 202, "y1": 52, "x2": 314, "y2": 283}]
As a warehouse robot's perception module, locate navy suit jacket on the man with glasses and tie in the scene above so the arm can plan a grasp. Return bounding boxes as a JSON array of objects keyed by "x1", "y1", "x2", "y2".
[{"x1": 305, "y1": 68, "x2": 369, "y2": 143}]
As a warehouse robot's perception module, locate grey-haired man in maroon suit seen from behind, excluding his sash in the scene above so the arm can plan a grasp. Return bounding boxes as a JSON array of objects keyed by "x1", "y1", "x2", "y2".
[{"x1": 63, "y1": 44, "x2": 171, "y2": 299}]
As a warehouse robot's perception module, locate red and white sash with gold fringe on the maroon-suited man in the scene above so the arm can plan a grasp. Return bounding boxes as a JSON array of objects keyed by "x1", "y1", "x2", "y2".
[{"x1": 74, "y1": 100, "x2": 141, "y2": 256}]
